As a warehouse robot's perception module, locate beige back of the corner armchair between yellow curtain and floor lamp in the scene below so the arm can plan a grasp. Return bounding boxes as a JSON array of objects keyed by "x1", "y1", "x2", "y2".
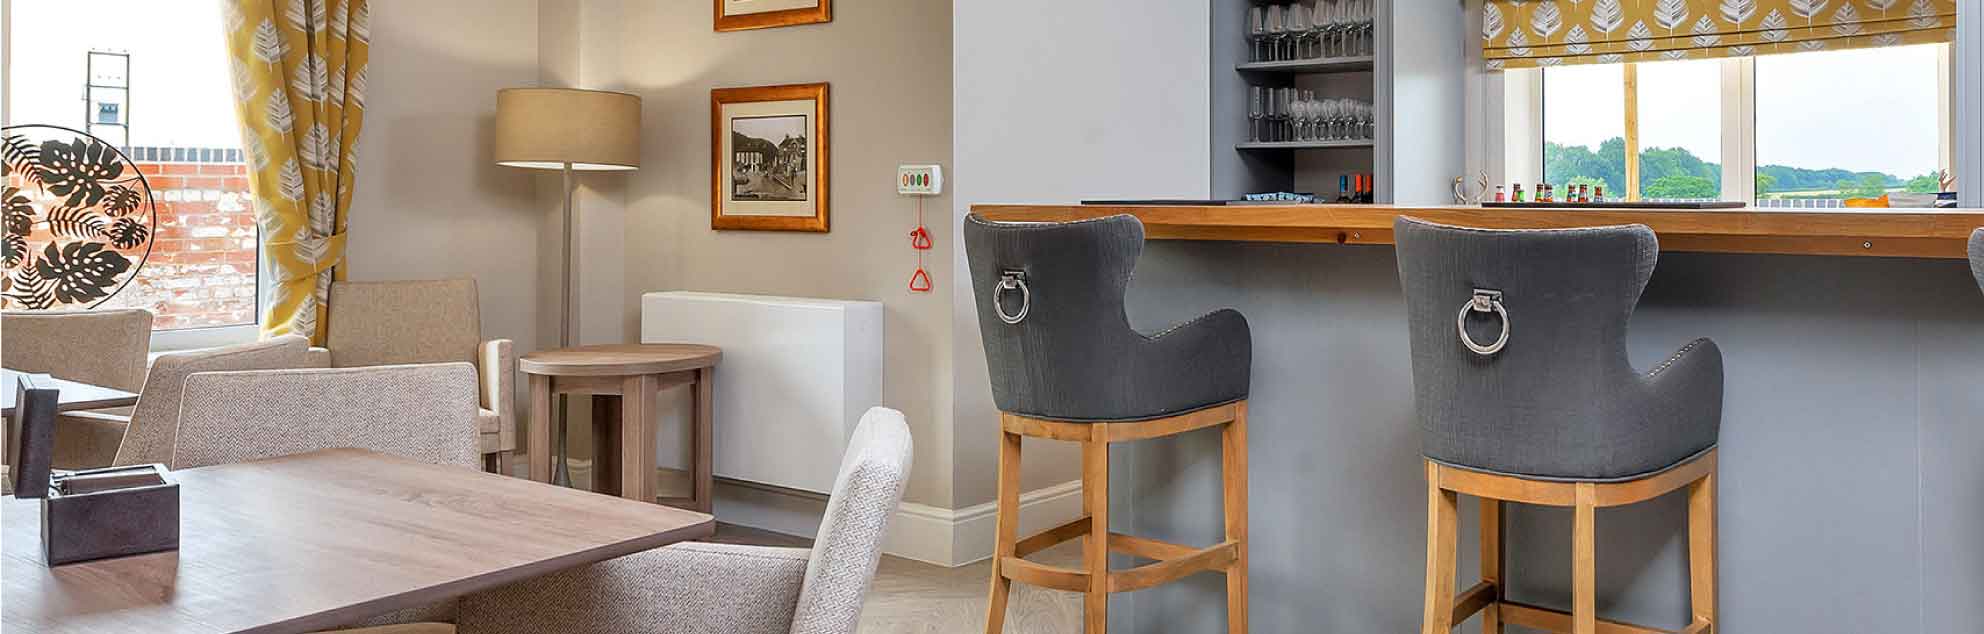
[{"x1": 323, "y1": 279, "x2": 482, "y2": 369}]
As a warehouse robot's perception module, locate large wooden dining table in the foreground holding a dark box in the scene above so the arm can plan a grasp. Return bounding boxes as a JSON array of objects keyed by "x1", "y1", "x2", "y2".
[{"x1": 0, "y1": 450, "x2": 714, "y2": 632}]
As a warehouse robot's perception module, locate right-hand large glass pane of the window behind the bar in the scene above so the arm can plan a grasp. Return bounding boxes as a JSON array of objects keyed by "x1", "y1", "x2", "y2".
[{"x1": 1756, "y1": 44, "x2": 1946, "y2": 206}]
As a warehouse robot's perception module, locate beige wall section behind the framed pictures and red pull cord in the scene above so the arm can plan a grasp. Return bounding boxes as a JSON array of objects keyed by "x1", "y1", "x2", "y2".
[{"x1": 599, "y1": 0, "x2": 954, "y2": 507}]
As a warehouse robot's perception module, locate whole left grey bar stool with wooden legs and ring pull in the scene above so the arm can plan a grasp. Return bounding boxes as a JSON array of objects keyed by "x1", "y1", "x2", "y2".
[{"x1": 964, "y1": 214, "x2": 1254, "y2": 634}]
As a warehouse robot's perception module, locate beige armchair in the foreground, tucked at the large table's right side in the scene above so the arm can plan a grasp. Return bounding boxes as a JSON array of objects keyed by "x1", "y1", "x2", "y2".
[{"x1": 456, "y1": 408, "x2": 911, "y2": 634}]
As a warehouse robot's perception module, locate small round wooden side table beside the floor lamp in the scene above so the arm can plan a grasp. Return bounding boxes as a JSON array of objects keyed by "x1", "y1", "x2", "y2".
[{"x1": 516, "y1": 343, "x2": 724, "y2": 513}]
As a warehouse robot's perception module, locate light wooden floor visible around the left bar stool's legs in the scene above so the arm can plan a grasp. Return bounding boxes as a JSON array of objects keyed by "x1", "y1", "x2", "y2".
[{"x1": 710, "y1": 523, "x2": 1081, "y2": 634}]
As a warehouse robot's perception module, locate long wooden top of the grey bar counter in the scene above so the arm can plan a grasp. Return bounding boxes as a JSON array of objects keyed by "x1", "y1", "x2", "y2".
[{"x1": 972, "y1": 204, "x2": 1984, "y2": 258}]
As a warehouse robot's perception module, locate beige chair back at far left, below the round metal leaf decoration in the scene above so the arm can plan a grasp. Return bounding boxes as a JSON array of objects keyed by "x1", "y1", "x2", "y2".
[{"x1": 0, "y1": 309, "x2": 151, "y2": 392}]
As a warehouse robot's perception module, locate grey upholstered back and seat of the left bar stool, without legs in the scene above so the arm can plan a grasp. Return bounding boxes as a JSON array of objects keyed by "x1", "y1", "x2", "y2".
[{"x1": 964, "y1": 214, "x2": 1252, "y2": 420}]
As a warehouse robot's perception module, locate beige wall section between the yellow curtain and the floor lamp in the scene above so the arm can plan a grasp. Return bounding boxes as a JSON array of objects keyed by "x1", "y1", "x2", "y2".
[{"x1": 347, "y1": 0, "x2": 558, "y2": 378}]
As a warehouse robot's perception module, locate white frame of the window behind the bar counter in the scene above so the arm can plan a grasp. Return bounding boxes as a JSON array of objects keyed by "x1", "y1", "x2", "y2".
[{"x1": 1482, "y1": 42, "x2": 1984, "y2": 210}]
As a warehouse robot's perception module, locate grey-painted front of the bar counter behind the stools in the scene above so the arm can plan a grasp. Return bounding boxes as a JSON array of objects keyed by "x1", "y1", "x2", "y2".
[{"x1": 1111, "y1": 242, "x2": 1984, "y2": 632}]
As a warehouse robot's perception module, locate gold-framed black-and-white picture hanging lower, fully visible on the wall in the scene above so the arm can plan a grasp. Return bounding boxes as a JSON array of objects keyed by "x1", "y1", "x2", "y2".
[{"x1": 710, "y1": 83, "x2": 831, "y2": 234}]
